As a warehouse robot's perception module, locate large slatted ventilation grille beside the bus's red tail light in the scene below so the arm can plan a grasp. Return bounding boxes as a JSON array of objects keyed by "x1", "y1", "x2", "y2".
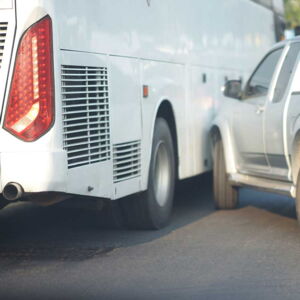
[{"x1": 61, "y1": 66, "x2": 110, "y2": 168}]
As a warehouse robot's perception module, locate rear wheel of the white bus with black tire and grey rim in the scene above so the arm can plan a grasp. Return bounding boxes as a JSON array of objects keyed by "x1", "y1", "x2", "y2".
[{"x1": 121, "y1": 118, "x2": 175, "y2": 229}]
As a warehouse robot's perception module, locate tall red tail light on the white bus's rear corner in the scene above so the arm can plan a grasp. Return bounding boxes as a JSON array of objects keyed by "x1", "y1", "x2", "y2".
[{"x1": 4, "y1": 16, "x2": 54, "y2": 142}]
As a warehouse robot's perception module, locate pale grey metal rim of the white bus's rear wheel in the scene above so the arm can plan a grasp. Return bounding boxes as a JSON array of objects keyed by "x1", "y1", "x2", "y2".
[{"x1": 154, "y1": 141, "x2": 171, "y2": 207}]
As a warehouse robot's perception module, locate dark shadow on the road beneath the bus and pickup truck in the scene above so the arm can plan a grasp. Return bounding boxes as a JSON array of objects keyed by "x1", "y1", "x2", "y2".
[{"x1": 0, "y1": 174, "x2": 296, "y2": 264}]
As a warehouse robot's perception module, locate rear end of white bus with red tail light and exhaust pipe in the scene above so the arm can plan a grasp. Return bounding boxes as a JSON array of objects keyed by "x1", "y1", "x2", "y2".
[{"x1": 0, "y1": 0, "x2": 66, "y2": 200}]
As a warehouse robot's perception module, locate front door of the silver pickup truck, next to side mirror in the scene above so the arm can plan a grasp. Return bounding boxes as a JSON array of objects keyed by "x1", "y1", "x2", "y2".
[{"x1": 232, "y1": 48, "x2": 283, "y2": 175}]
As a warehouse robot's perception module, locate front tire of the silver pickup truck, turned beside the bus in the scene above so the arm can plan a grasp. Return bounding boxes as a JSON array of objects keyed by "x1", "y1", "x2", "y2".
[{"x1": 213, "y1": 139, "x2": 238, "y2": 209}]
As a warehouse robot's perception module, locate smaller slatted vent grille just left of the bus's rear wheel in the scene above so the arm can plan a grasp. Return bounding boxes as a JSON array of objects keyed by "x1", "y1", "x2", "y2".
[{"x1": 113, "y1": 141, "x2": 141, "y2": 182}]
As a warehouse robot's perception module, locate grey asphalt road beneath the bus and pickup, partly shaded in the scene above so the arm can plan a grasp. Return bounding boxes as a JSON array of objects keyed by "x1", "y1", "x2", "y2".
[{"x1": 0, "y1": 176, "x2": 300, "y2": 300}]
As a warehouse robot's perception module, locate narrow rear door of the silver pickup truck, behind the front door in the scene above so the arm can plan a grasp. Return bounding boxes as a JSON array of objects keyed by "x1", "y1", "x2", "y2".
[{"x1": 264, "y1": 43, "x2": 300, "y2": 180}]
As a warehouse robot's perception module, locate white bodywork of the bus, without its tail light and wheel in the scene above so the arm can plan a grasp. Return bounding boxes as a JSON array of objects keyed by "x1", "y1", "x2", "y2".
[{"x1": 0, "y1": 0, "x2": 282, "y2": 203}]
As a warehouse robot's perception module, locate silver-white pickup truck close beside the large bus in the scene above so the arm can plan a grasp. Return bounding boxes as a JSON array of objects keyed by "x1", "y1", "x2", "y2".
[{"x1": 211, "y1": 38, "x2": 300, "y2": 220}]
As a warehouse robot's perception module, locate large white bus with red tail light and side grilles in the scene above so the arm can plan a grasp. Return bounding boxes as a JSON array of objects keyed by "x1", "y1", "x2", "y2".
[{"x1": 0, "y1": 0, "x2": 283, "y2": 228}]
